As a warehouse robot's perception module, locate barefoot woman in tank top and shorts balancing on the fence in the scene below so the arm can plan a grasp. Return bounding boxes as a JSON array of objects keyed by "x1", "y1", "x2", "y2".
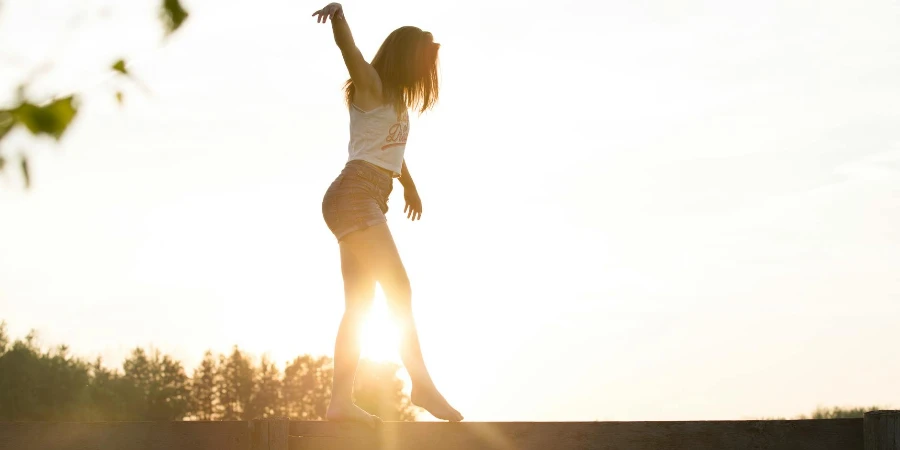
[{"x1": 313, "y1": 3, "x2": 462, "y2": 426}]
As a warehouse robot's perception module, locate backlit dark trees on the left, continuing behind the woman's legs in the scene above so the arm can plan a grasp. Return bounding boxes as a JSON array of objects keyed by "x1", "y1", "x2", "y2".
[{"x1": 0, "y1": 322, "x2": 420, "y2": 422}]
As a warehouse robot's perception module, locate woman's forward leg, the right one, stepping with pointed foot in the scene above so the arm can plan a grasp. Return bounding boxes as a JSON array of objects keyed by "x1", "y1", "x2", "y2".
[{"x1": 342, "y1": 224, "x2": 463, "y2": 421}]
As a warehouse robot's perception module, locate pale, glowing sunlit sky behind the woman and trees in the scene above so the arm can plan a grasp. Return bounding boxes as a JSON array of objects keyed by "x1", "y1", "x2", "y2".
[{"x1": 0, "y1": 0, "x2": 900, "y2": 421}]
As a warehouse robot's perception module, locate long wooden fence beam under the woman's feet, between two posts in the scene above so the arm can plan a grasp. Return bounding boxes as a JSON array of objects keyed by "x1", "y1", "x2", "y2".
[{"x1": 290, "y1": 419, "x2": 856, "y2": 450}]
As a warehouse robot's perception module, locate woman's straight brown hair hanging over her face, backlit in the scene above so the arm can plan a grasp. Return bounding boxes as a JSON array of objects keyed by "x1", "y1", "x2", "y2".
[{"x1": 344, "y1": 26, "x2": 440, "y2": 114}]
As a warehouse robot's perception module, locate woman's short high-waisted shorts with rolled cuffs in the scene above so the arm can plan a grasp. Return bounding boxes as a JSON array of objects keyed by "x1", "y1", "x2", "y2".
[{"x1": 322, "y1": 160, "x2": 394, "y2": 242}]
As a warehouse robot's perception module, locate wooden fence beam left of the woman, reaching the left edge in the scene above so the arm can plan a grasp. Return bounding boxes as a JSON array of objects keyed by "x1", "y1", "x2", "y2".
[{"x1": 0, "y1": 421, "x2": 251, "y2": 450}]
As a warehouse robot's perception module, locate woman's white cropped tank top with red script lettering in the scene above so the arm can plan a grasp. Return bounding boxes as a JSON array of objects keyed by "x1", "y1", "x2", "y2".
[{"x1": 347, "y1": 103, "x2": 409, "y2": 178}]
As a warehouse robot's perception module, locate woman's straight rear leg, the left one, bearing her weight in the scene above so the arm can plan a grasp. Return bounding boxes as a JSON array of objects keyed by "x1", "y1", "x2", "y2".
[{"x1": 325, "y1": 243, "x2": 378, "y2": 425}]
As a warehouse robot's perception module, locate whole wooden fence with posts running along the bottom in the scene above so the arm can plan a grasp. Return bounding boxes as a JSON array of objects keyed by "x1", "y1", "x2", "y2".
[{"x1": 0, "y1": 411, "x2": 900, "y2": 450}]
